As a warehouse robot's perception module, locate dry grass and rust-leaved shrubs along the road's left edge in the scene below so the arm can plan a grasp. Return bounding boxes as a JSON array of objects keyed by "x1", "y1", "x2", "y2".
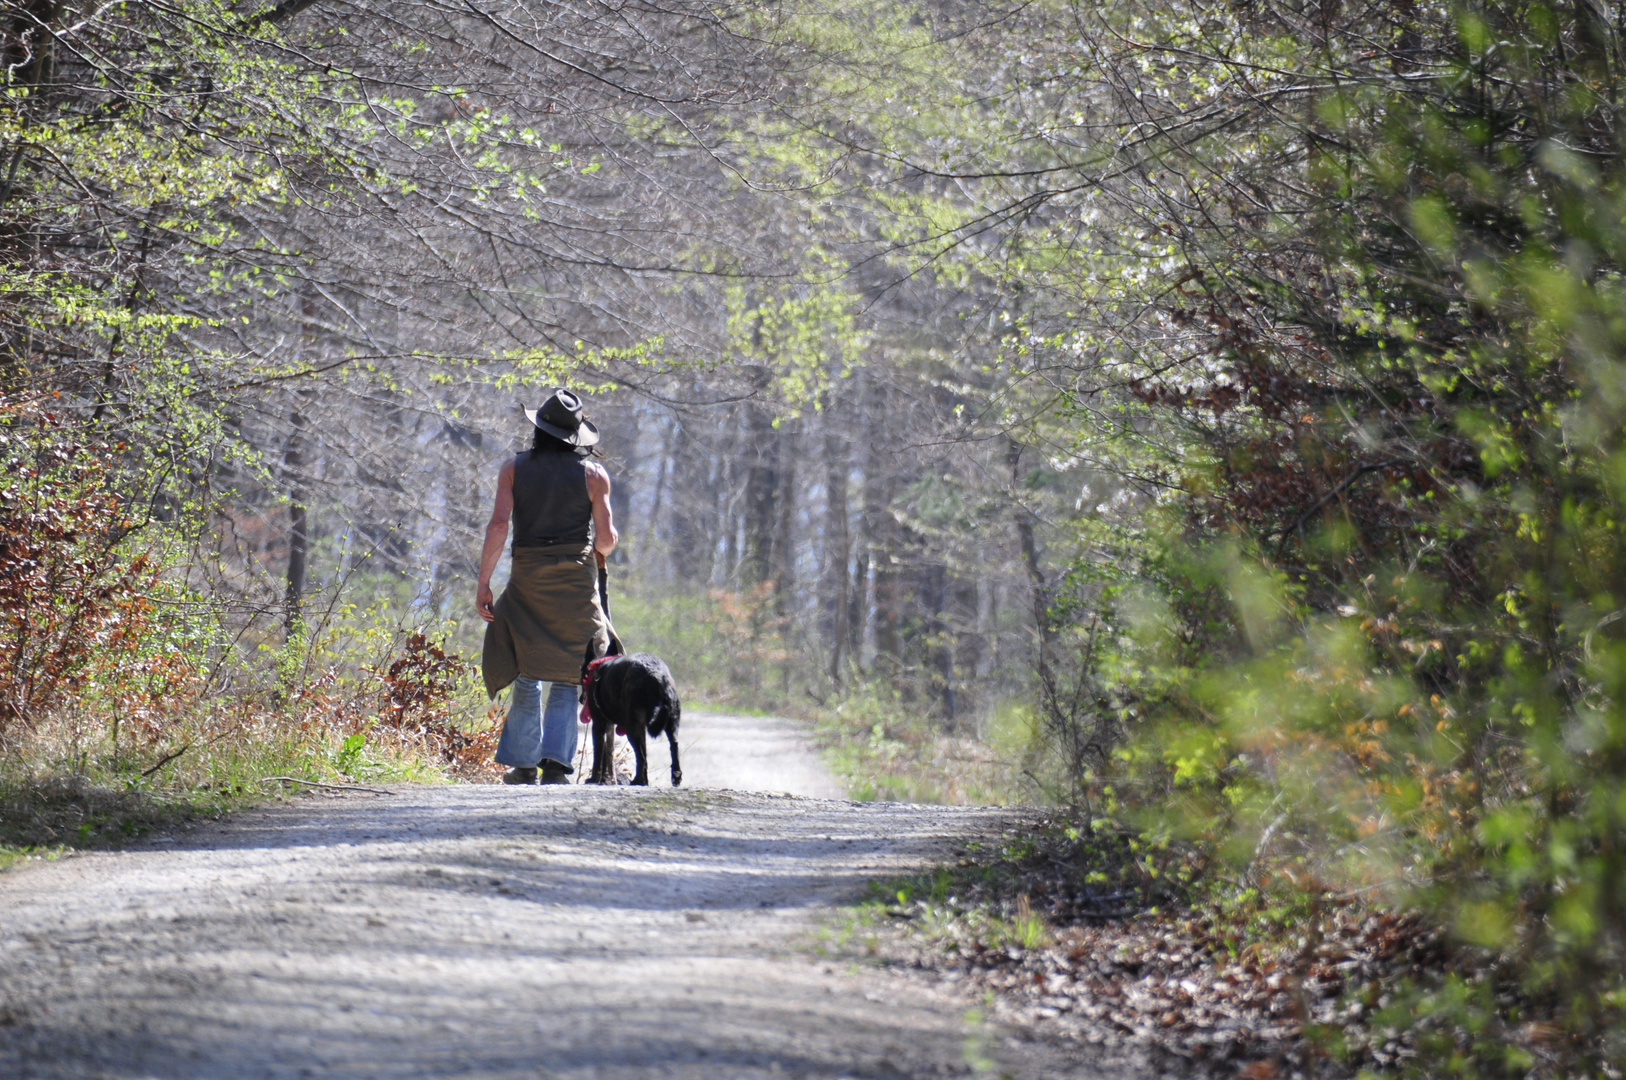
[{"x1": 0, "y1": 391, "x2": 494, "y2": 862}]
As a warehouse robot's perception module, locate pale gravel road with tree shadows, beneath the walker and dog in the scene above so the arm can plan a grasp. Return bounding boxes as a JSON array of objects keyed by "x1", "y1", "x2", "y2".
[{"x1": 0, "y1": 716, "x2": 1125, "y2": 1080}]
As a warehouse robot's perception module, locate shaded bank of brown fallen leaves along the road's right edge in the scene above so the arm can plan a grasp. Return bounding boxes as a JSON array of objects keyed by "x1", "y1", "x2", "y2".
[{"x1": 820, "y1": 813, "x2": 1561, "y2": 1080}]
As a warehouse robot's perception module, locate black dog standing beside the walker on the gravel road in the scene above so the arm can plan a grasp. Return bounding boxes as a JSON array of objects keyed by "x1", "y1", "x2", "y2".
[{"x1": 582, "y1": 639, "x2": 683, "y2": 787}]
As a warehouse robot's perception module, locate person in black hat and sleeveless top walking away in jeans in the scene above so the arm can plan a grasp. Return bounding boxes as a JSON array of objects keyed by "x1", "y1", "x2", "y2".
[{"x1": 475, "y1": 389, "x2": 620, "y2": 784}]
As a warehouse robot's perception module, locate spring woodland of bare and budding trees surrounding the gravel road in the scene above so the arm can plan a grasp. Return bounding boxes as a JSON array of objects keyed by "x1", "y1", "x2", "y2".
[{"x1": 0, "y1": 0, "x2": 1626, "y2": 1080}]
